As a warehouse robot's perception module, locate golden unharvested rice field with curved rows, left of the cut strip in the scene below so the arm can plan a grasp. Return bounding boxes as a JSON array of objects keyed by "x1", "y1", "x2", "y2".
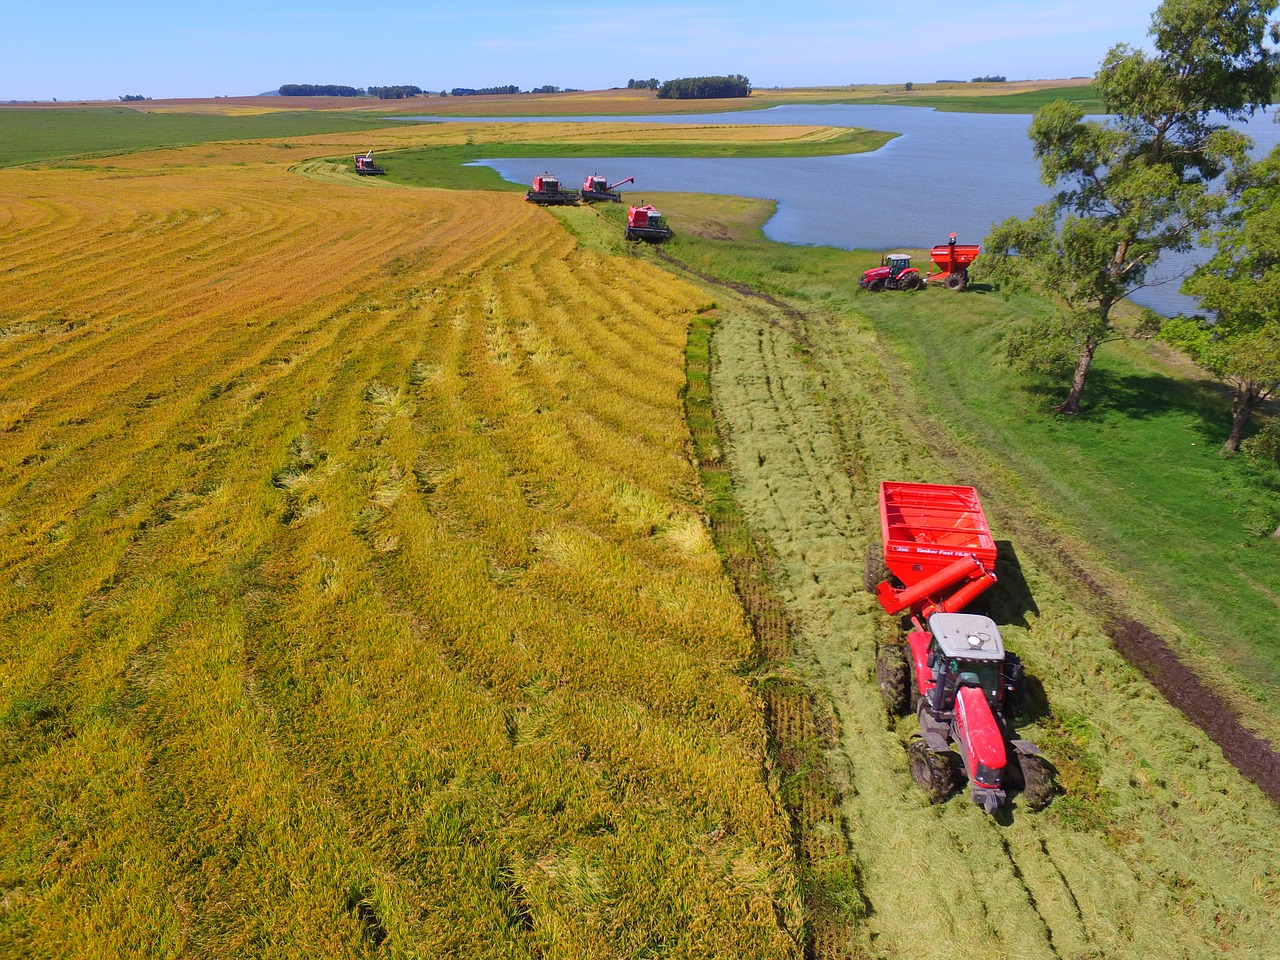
[{"x1": 0, "y1": 131, "x2": 804, "y2": 957}]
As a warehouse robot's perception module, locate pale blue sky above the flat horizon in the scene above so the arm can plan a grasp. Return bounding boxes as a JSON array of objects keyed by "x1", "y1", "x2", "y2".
[{"x1": 0, "y1": 0, "x2": 1157, "y2": 100}]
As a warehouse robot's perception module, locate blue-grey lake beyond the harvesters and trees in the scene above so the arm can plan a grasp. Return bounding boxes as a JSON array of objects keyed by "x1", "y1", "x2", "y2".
[{"x1": 407, "y1": 104, "x2": 1280, "y2": 314}]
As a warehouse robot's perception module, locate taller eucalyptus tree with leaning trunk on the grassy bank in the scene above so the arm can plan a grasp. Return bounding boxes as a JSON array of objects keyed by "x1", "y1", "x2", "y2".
[{"x1": 986, "y1": 0, "x2": 1280, "y2": 413}]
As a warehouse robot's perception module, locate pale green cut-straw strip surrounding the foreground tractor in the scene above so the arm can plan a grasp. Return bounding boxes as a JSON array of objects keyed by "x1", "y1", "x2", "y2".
[{"x1": 712, "y1": 273, "x2": 1280, "y2": 957}]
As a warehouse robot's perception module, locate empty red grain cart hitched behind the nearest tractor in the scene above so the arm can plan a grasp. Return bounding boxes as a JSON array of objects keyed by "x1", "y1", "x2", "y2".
[{"x1": 867, "y1": 481, "x2": 996, "y2": 617}]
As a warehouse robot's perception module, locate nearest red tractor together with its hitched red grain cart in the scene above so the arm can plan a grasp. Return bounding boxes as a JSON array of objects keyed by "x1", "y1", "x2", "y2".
[{"x1": 867, "y1": 483, "x2": 1057, "y2": 814}]
